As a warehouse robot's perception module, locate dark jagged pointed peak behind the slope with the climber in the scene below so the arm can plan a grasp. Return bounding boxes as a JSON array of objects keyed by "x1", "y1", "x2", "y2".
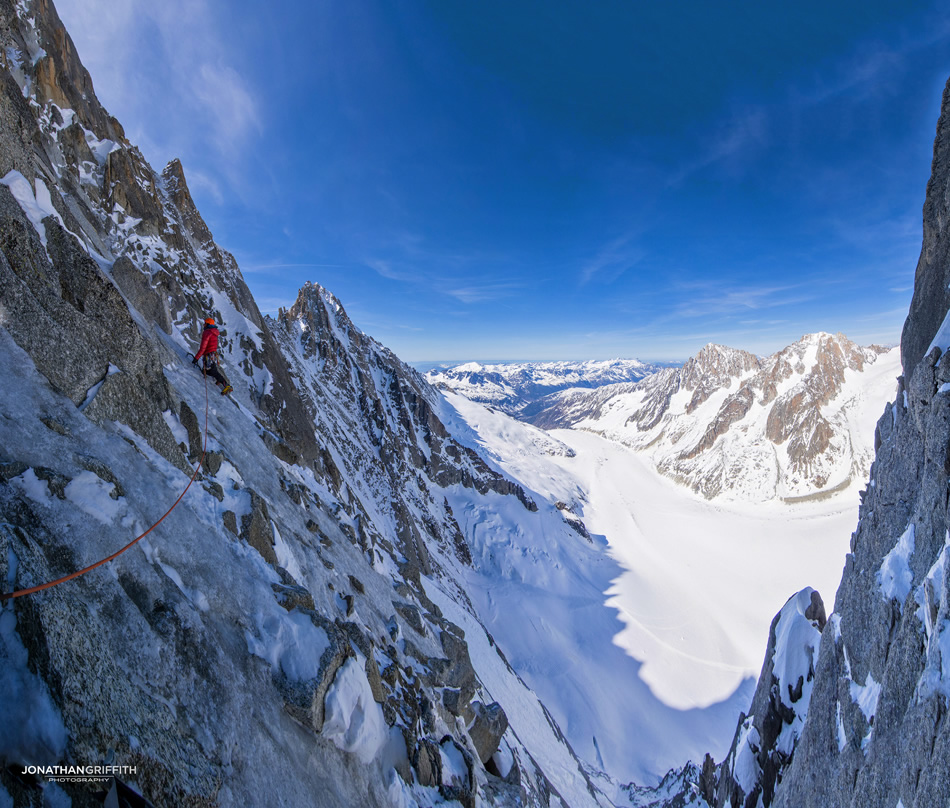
[{"x1": 269, "y1": 283, "x2": 538, "y2": 577}]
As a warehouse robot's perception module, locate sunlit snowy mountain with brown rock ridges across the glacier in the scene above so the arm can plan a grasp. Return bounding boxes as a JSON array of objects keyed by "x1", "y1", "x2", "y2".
[{"x1": 527, "y1": 334, "x2": 897, "y2": 501}]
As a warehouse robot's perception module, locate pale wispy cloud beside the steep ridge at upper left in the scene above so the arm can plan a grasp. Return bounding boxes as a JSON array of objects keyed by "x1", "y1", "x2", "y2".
[{"x1": 56, "y1": 0, "x2": 263, "y2": 191}]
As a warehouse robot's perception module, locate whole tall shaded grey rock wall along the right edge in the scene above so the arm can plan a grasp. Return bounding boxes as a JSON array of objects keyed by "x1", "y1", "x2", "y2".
[{"x1": 713, "y1": 74, "x2": 950, "y2": 808}]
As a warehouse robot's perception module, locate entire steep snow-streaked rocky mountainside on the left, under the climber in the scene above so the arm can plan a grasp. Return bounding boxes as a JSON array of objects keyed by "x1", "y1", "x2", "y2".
[{"x1": 0, "y1": 0, "x2": 605, "y2": 806}]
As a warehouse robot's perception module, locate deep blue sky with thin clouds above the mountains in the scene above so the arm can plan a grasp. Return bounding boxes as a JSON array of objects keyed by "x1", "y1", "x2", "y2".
[{"x1": 57, "y1": 0, "x2": 950, "y2": 361}]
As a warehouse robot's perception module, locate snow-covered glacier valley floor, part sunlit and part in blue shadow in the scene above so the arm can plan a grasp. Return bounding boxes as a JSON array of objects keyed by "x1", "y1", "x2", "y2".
[{"x1": 436, "y1": 388, "x2": 887, "y2": 783}]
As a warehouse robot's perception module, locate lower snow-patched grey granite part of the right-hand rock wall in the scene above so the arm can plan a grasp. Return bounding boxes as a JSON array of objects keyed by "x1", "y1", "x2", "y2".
[{"x1": 776, "y1": 342, "x2": 950, "y2": 808}]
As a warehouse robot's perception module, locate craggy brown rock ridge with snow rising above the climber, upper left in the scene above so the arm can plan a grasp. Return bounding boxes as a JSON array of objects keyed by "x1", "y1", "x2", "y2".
[{"x1": 0, "y1": 0, "x2": 316, "y2": 470}]
